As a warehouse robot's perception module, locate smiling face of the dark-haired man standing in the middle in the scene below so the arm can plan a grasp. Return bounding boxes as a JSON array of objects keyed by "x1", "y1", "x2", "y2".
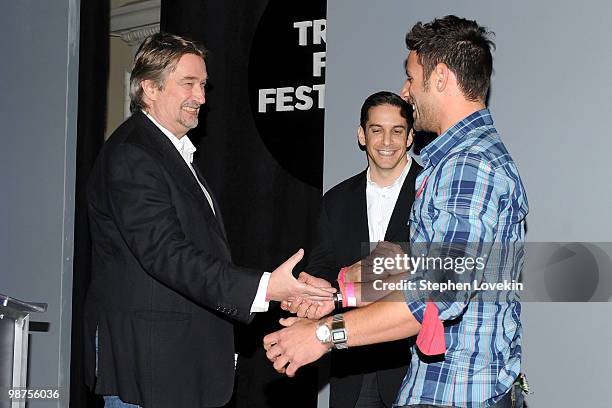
[{"x1": 358, "y1": 105, "x2": 412, "y2": 186}]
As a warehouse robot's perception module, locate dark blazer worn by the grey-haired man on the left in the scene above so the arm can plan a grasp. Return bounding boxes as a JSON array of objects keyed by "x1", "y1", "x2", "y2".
[{"x1": 85, "y1": 112, "x2": 262, "y2": 408}]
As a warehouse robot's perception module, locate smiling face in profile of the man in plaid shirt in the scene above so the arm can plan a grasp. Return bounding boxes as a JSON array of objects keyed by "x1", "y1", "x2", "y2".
[{"x1": 400, "y1": 51, "x2": 437, "y2": 132}]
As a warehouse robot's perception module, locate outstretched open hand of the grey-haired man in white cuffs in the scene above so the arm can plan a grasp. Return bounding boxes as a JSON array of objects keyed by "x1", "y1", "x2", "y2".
[{"x1": 266, "y1": 248, "x2": 336, "y2": 302}]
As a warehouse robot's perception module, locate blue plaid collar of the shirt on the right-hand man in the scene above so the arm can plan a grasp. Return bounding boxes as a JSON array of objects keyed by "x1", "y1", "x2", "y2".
[{"x1": 421, "y1": 108, "x2": 493, "y2": 167}]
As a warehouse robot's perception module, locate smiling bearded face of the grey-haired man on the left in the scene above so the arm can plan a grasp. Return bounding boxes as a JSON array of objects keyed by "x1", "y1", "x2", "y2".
[{"x1": 142, "y1": 54, "x2": 208, "y2": 139}]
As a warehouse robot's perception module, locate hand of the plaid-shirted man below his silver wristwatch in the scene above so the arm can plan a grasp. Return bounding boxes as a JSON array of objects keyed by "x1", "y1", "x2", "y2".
[{"x1": 264, "y1": 317, "x2": 330, "y2": 377}]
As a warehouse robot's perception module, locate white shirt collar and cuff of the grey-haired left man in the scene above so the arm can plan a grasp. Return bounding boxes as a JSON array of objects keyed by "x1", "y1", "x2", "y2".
[{"x1": 143, "y1": 111, "x2": 270, "y2": 313}]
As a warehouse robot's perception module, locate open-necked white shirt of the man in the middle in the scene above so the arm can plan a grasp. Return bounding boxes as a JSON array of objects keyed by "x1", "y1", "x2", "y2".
[{"x1": 366, "y1": 156, "x2": 412, "y2": 242}]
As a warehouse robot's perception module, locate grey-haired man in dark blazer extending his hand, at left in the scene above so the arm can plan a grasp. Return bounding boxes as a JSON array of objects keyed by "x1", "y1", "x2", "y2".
[{"x1": 85, "y1": 33, "x2": 330, "y2": 408}]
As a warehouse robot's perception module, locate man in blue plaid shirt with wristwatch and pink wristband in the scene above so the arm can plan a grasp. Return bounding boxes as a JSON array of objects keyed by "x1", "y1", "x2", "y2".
[{"x1": 264, "y1": 16, "x2": 528, "y2": 408}]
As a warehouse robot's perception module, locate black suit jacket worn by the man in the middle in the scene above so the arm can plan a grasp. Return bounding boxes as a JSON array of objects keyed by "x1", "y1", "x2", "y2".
[{"x1": 306, "y1": 160, "x2": 421, "y2": 408}]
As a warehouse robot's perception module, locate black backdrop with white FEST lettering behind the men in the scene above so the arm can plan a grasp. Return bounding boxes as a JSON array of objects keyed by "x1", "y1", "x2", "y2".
[{"x1": 161, "y1": 0, "x2": 326, "y2": 407}]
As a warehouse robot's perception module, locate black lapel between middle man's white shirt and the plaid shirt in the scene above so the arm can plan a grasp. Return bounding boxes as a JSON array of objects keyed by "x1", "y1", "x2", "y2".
[{"x1": 385, "y1": 159, "x2": 422, "y2": 242}]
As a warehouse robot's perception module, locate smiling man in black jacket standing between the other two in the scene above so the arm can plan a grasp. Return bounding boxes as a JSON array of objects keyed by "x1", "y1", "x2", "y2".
[{"x1": 289, "y1": 92, "x2": 421, "y2": 408}]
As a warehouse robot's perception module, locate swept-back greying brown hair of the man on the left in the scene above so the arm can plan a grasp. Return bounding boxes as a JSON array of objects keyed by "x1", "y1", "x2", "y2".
[{"x1": 130, "y1": 33, "x2": 206, "y2": 113}]
